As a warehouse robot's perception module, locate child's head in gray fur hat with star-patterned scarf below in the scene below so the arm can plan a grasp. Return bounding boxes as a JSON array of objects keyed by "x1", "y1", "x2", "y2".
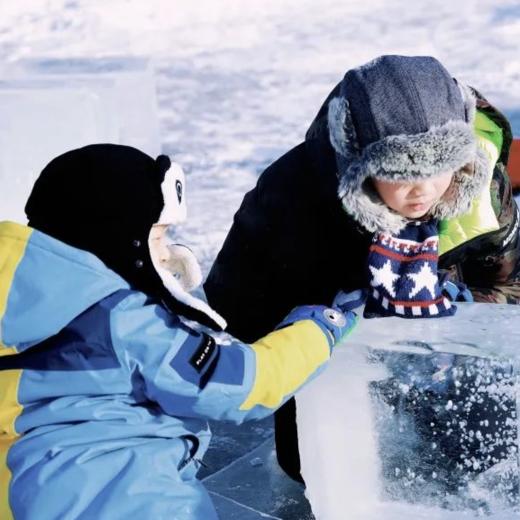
[{"x1": 328, "y1": 56, "x2": 504, "y2": 318}]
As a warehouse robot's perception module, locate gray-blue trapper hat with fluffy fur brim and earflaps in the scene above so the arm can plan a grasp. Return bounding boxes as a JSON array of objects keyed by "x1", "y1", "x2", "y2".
[{"x1": 328, "y1": 56, "x2": 491, "y2": 233}]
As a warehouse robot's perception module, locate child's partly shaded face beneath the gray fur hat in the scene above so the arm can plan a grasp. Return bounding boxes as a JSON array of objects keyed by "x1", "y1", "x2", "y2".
[{"x1": 374, "y1": 173, "x2": 453, "y2": 218}]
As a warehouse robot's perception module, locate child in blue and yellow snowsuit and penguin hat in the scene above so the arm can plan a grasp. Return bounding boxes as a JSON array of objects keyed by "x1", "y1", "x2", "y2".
[{"x1": 0, "y1": 145, "x2": 355, "y2": 520}]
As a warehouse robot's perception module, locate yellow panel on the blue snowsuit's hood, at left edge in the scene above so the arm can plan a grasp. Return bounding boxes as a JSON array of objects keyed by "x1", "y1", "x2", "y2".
[{"x1": 0, "y1": 222, "x2": 32, "y2": 356}]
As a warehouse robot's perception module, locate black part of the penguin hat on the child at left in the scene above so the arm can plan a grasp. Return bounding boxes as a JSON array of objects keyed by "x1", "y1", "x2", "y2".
[{"x1": 25, "y1": 144, "x2": 221, "y2": 330}]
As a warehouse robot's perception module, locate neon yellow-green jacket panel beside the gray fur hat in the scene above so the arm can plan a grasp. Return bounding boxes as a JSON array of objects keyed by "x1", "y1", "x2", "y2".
[{"x1": 439, "y1": 116, "x2": 500, "y2": 255}]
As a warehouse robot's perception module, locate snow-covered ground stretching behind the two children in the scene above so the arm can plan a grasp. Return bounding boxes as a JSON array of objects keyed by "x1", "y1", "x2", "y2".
[{"x1": 0, "y1": 0, "x2": 520, "y2": 518}]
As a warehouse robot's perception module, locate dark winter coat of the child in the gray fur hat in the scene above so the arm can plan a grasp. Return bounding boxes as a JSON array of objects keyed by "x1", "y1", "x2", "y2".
[{"x1": 205, "y1": 88, "x2": 520, "y2": 480}]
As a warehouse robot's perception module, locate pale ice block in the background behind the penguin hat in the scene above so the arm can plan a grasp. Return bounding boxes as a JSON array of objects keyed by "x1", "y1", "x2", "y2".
[{"x1": 0, "y1": 57, "x2": 160, "y2": 222}]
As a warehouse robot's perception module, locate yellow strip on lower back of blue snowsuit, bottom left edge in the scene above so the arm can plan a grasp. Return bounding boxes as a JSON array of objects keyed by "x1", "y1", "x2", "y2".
[{"x1": 0, "y1": 370, "x2": 23, "y2": 520}]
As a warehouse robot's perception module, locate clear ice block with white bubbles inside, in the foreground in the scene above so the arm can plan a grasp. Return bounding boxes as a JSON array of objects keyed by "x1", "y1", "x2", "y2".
[{"x1": 296, "y1": 304, "x2": 520, "y2": 520}]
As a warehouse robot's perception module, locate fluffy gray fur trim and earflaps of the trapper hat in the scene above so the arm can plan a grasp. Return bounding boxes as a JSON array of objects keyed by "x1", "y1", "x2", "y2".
[{"x1": 327, "y1": 57, "x2": 492, "y2": 234}]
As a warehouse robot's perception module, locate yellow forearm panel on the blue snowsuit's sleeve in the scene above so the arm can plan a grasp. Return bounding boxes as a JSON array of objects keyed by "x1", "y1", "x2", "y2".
[{"x1": 240, "y1": 320, "x2": 330, "y2": 410}]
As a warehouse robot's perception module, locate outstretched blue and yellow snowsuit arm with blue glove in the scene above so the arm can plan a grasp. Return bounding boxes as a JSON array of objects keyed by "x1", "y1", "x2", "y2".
[{"x1": 107, "y1": 293, "x2": 356, "y2": 423}]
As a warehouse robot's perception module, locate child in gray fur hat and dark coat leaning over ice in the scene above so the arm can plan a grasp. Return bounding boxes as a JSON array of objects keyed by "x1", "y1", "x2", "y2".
[{"x1": 205, "y1": 56, "x2": 520, "y2": 479}]
